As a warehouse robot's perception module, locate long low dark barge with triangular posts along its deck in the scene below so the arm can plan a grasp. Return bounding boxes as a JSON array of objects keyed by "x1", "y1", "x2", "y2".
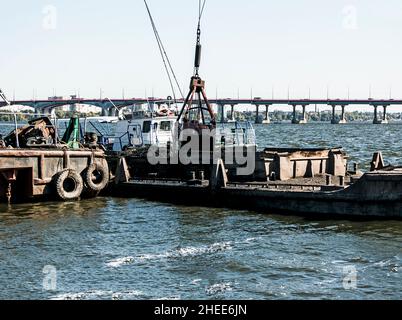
[{"x1": 108, "y1": 153, "x2": 402, "y2": 219}]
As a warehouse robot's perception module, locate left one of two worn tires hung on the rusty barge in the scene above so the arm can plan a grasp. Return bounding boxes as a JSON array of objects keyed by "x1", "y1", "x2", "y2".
[{"x1": 54, "y1": 169, "x2": 84, "y2": 201}]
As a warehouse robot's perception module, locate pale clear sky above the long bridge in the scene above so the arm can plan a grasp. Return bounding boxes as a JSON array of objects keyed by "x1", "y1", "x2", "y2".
[{"x1": 0, "y1": 0, "x2": 402, "y2": 110}]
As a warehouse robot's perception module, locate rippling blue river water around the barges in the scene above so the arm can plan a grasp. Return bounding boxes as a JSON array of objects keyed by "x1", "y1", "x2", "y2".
[{"x1": 0, "y1": 124, "x2": 402, "y2": 299}]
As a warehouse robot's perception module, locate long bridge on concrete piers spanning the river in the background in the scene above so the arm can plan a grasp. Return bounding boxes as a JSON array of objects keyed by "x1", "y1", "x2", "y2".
[{"x1": 0, "y1": 97, "x2": 402, "y2": 124}]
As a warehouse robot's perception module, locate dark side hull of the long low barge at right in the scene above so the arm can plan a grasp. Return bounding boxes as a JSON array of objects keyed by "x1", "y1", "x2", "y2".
[{"x1": 110, "y1": 171, "x2": 402, "y2": 219}]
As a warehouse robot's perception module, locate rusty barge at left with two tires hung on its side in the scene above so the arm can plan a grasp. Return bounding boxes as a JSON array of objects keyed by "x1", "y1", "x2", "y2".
[{"x1": 0, "y1": 111, "x2": 109, "y2": 203}]
